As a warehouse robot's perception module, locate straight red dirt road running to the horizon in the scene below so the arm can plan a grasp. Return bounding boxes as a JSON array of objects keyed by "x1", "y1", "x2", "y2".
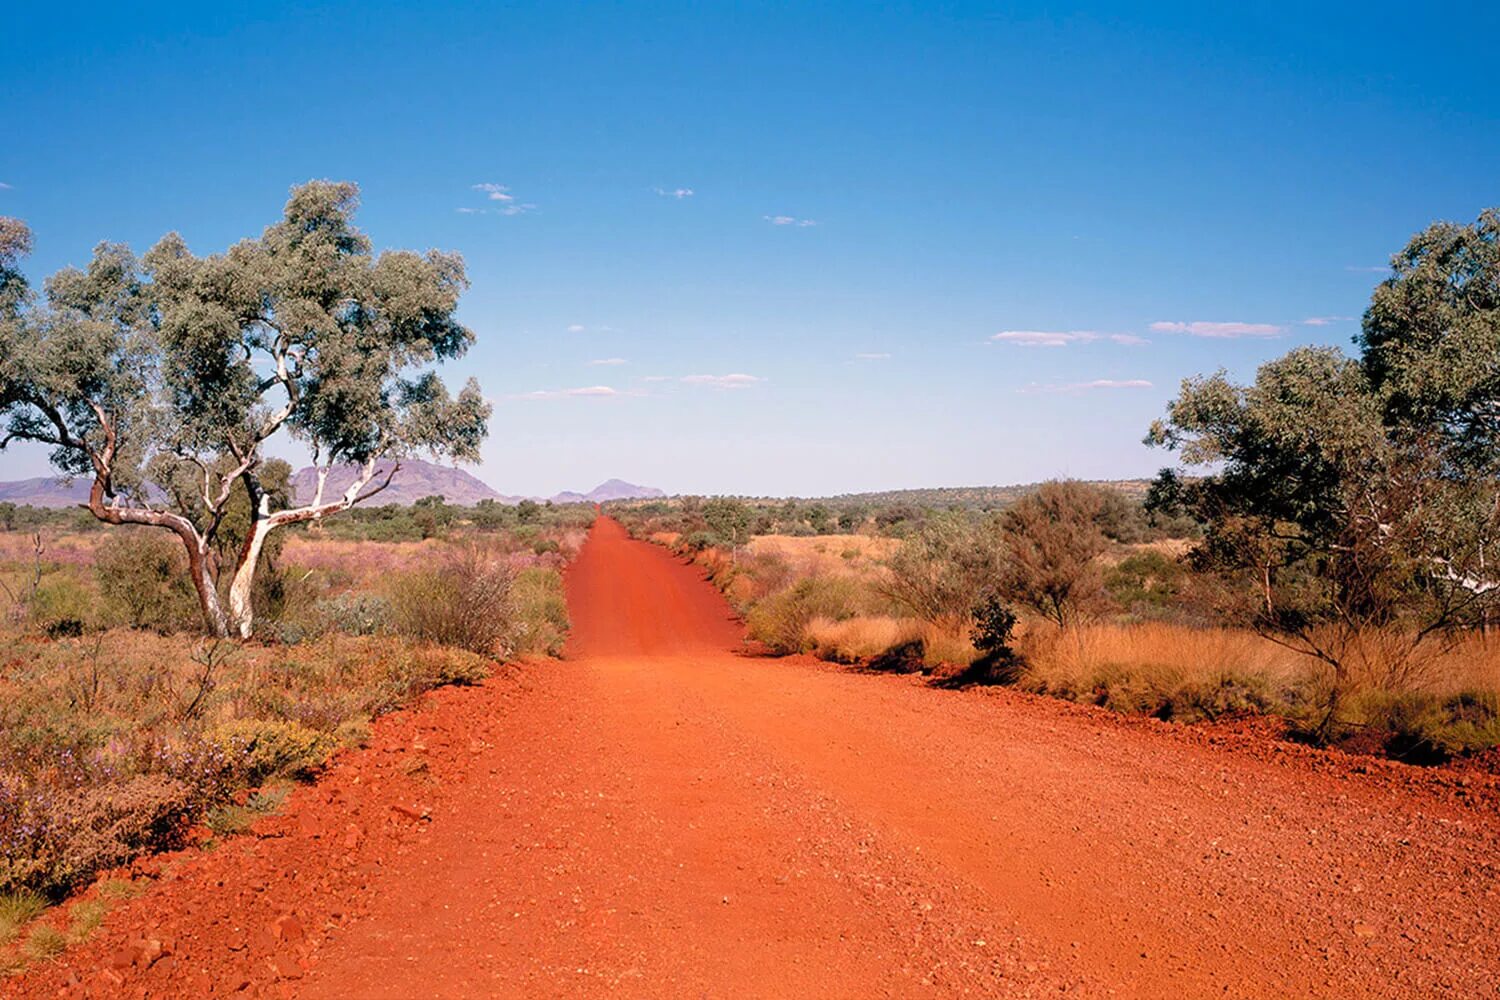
[{"x1": 11, "y1": 519, "x2": 1500, "y2": 999}]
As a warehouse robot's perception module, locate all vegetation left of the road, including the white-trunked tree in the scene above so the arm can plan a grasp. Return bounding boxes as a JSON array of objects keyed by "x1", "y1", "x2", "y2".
[{"x1": 0, "y1": 181, "x2": 594, "y2": 967}]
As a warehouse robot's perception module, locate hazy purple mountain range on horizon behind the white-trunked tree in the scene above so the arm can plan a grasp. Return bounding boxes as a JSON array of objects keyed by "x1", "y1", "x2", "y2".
[{"x1": 0, "y1": 459, "x2": 666, "y2": 507}]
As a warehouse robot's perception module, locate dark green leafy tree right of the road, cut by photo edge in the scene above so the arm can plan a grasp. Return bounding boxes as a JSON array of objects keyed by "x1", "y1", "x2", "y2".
[{"x1": 1146, "y1": 211, "x2": 1500, "y2": 735}]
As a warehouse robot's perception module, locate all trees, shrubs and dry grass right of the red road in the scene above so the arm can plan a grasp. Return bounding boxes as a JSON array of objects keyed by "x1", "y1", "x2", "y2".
[{"x1": 611, "y1": 210, "x2": 1500, "y2": 766}]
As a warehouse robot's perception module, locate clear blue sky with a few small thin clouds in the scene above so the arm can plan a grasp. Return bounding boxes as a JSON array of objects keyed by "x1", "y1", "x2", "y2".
[{"x1": 0, "y1": 1, "x2": 1500, "y2": 495}]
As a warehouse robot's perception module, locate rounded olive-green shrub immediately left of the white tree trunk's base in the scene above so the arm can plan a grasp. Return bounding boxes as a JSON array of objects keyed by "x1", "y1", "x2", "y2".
[{"x1": 95, "y1": 531, "x2": 200, "y2": 633}]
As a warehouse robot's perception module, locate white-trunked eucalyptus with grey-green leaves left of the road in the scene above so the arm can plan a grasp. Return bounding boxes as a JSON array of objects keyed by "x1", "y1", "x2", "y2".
[{"x1": 0, "y1": 181, "x2": 491, "y2": 636}]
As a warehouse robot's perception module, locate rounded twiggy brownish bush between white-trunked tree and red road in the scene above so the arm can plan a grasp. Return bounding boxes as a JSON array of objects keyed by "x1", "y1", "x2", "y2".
[{"x1": 392, "y1": 546, "x2": 515, "y2": 657}]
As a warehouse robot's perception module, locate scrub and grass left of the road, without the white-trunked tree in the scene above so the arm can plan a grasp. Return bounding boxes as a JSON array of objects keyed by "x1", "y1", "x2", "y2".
[{"x1": 0, "y1": 498, "x2": 594, "y2": 964}]
